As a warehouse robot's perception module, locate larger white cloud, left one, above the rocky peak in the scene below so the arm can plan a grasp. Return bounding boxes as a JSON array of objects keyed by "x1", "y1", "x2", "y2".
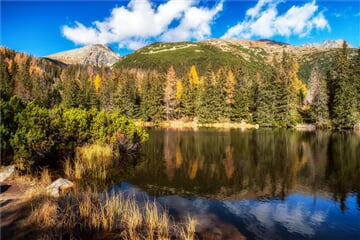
[{"x1": 62, "y1": 0, "x2": 222, "y2": 49}]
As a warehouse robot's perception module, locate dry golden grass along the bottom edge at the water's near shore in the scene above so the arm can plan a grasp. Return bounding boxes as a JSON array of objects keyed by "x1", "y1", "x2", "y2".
[{"x1": 28, "y1": 189, "x2": 195, "y2": 240}]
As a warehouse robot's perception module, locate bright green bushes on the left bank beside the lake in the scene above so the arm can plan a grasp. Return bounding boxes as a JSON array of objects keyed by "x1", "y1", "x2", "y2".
[{"x1": 0, "y1": 96, "x2": 147, "y2": 167}]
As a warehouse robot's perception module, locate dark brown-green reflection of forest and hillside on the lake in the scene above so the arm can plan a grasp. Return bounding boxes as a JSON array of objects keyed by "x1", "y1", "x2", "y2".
[{"x1": 127, "y1": 129, "x2": 360, "y2": 210}]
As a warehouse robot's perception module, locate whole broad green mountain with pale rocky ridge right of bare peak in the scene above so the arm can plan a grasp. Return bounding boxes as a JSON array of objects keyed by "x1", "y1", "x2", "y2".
[{"x1": 114, "y1": 39, "x2": 355, "y2": 82}]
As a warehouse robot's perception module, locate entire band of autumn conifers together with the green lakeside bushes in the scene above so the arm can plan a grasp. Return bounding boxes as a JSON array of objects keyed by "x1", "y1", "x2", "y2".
[{"x1": 0, "y1": 43, "x2": 360, "y2": 167}]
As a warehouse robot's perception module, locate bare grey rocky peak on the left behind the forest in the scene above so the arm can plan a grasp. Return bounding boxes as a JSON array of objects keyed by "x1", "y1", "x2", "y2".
[{"x1": 46, "y1": 44, "x2": 120, "y2": 66}]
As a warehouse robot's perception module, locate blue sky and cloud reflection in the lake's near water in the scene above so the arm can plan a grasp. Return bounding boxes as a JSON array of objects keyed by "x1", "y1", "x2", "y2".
[{"x1": 111, "y1": 183, "x2": 360, "y2": 240}]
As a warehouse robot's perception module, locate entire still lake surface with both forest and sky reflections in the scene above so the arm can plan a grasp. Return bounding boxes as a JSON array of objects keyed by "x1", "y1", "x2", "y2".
[{"x1": 113, "y1": 129, "x2": 360, "y2": 239}]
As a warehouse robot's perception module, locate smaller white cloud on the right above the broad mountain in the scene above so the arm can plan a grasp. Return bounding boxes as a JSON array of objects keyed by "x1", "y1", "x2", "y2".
[{"x1": 223, "y1": 0, "x2": 330, "y2": 39}]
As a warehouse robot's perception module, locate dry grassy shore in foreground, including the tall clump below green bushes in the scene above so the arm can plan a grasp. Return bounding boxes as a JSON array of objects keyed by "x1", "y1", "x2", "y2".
[{"x1": 1, "y1": 144, "x2": 196, "y2": 240}]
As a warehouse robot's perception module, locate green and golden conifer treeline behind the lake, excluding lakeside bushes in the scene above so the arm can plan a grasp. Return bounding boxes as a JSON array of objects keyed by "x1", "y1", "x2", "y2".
[{"x1": 1, "y1": 43, "x2": 360, "y2": 128}]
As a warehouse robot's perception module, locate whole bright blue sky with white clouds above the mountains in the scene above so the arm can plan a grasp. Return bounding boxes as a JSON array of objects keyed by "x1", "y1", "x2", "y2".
[{"x1": 0, "y1": 0, "x2": 360, "y2": 56}]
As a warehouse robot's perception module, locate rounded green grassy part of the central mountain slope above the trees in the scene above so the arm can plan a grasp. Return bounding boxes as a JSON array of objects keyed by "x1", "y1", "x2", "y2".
[{"x1": 114, "y1": 42, "x2": 258, "y2": 76}]
